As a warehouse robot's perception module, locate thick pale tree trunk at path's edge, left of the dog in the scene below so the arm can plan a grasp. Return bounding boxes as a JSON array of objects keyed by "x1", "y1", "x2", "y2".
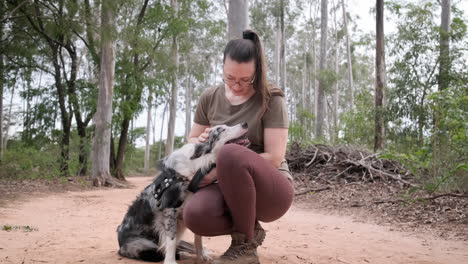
[{"x1": 91, "y1": 0, "x2": 115, "y2": 186}]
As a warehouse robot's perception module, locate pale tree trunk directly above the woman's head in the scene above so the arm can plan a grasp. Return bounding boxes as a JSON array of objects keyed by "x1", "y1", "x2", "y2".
[{"x1": 228, "y1": 0, "x2": 249, "y2": 40}]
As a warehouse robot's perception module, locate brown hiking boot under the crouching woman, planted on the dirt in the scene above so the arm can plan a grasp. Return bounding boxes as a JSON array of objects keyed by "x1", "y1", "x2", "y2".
[{"x1": 213, "y1": 232, "x2": 265, "y2": 264}]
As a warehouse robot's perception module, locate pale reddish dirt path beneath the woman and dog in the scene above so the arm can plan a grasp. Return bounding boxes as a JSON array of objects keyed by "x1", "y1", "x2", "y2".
[{"x1": 0, "y1": 178, "x2": 468, "y2": 264}]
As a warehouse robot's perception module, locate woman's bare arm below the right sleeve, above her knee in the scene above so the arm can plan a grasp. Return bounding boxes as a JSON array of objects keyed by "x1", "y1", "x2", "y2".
[{"x1": 260, "y1": 128, "x2": 288, "y2": 168}]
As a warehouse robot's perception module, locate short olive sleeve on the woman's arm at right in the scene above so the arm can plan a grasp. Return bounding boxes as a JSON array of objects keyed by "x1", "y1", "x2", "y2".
[{"x1": 262, "y1": 96, "x2": 289, "y2": 128}]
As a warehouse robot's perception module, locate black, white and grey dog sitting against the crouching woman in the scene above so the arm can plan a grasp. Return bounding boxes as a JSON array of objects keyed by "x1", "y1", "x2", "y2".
[{"x1": 117, "y1": 123, "x2": 248, "y2": 264}]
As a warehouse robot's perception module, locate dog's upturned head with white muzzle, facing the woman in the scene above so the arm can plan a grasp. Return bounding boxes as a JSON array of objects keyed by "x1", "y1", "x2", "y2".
[{"x1": 190, "y1": 122, "x2": 250, "y2": 159}]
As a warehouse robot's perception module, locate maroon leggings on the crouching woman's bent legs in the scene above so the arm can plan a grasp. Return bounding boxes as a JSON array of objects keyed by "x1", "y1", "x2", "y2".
[{"x1": 183, "y1": 144, "x2": 294, "y2": 239}]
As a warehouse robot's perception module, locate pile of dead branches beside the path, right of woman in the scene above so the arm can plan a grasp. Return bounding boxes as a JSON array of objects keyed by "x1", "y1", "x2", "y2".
[{"x1": 286, "y1": 143, "x2": 415, "y2": 186}]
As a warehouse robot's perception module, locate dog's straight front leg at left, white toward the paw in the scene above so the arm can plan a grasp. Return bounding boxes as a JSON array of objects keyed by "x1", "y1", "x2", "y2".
[{"x1": 164, "y1": 208, "x2": 177, "y2": 264}]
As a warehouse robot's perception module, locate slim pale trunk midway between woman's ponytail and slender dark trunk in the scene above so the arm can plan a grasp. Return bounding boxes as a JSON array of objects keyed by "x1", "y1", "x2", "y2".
[{"x1": 315, "y1": 0, "x2": 328, "y2": 139}]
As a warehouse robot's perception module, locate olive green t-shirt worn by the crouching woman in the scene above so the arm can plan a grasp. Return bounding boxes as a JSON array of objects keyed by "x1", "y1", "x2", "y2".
[{"x1": 194, "y1": 84, "x2": 289, "y2": 153}]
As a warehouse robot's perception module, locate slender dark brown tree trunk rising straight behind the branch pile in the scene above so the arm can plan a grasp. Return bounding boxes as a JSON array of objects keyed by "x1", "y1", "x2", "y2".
[{"x1": 374, "y1": 0, "x2": 386, "y2": 151}]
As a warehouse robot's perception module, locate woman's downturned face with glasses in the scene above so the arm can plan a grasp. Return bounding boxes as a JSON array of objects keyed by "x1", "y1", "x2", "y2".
[{"x1": 223, "y1": 56, "x2": 255, "y2": 96}]
